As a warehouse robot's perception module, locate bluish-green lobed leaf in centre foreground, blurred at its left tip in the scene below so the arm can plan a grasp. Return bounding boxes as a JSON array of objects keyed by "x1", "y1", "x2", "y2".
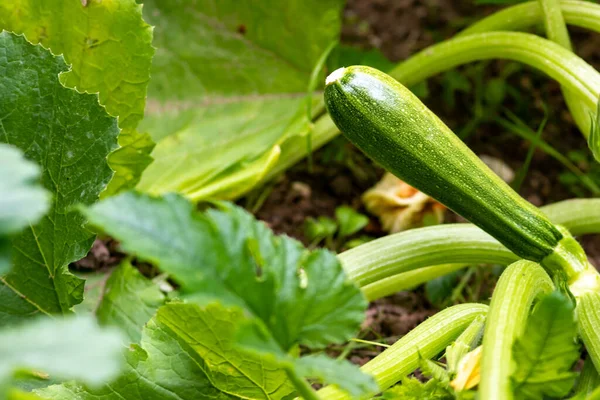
[{"x1": 84, "y1": 192, "x2": 367, "y2": 352}]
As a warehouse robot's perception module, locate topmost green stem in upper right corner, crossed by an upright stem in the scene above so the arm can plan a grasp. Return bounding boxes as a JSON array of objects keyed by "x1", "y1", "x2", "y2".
[{"x1": 459, "y1": 0, "x2": 600, "y2": 36}]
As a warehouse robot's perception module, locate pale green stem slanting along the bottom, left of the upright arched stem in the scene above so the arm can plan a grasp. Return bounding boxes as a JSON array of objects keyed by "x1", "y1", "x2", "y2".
[{"x1": 318, "y1": 304, "x2": 488, "y2": 400}]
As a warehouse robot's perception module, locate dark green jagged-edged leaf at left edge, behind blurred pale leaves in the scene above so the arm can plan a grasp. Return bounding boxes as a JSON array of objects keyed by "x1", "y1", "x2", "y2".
[{"x1": 0, "y1": 32, "x2": 119, "y2": 326}]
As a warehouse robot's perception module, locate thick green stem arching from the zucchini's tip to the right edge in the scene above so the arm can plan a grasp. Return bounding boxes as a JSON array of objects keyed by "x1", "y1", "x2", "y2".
[{"x1": 390, "y1": 32, "x2": 600, "y2": 136}]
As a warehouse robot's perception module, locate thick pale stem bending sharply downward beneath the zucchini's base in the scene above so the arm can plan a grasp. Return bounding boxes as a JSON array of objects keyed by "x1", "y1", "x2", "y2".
[{"x1": 479, "y1": 260, "x2": 554, "y2": 400}]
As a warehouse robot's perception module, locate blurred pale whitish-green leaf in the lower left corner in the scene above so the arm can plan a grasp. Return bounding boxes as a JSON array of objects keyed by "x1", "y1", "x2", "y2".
[{"x1": 0, "y1": 317, "x2": 123, "y2": 390}]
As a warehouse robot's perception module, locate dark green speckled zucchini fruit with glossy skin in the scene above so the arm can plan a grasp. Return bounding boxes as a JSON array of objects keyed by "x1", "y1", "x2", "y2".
[{"x1": 325, "y1": 66, "x2": 563, "y2": 262}]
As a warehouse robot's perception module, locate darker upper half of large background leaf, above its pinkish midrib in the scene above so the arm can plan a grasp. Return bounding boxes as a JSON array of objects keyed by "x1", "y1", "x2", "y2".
[{"x1": 144, "y1": 0, "x2": 344, "y2": 102}]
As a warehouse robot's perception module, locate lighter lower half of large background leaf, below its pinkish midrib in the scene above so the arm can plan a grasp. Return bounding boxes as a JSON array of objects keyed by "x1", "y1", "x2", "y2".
[{"x1": 138, "y1": 96, "x2": 308, "y2": 201}]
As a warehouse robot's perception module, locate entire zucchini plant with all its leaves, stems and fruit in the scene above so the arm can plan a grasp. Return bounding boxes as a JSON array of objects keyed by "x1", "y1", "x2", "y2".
[{"x1": 0, "y1": 0, "x2": 600, "y2": 400}]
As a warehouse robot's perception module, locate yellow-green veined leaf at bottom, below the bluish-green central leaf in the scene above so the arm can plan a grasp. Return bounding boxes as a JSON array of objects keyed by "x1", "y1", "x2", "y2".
[{"x1": 38, "y1": 303, "x2": 292, "y2": 400}]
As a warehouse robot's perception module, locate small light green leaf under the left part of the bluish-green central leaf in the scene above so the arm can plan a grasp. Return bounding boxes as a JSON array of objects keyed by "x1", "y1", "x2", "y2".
[{"x1": 96, "y1": 261, "x2": 165, "y2": 343}]
